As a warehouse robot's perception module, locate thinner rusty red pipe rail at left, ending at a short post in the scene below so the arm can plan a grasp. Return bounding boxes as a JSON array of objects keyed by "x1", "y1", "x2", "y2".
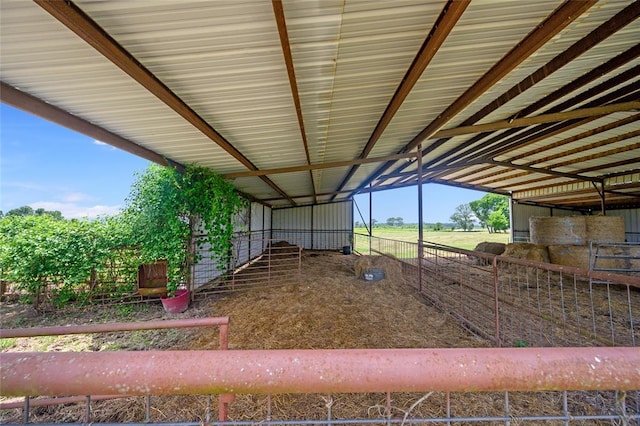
[{"x1": 0, "y1": 317, "x2": 229, "y2": 339}]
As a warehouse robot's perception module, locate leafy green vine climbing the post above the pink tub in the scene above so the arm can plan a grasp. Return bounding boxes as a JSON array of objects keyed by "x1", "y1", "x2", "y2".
[{"x1": 124, "y1": 165, "x2": 246, "y2": 294}]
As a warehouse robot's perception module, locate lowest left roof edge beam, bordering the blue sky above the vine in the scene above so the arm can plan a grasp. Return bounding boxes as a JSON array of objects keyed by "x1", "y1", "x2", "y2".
[{"x1": 0, "y1": 82, "x2": 175, "y2": 169}]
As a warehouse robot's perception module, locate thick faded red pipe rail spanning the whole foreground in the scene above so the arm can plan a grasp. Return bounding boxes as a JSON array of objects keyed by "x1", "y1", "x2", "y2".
[{"x1": 0, "y1": 347, "x2": 640, "y2": 396}]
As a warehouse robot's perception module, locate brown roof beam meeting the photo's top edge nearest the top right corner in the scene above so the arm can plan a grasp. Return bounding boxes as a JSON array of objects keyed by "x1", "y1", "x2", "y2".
[{"x1": 350, "y1": 0, "x2": 596, "y2": 196}]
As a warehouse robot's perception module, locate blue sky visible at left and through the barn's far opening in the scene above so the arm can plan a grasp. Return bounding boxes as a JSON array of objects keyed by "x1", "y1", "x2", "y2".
[{"x1": 0, "y1": 105, "x2": 484, "y2": 223}]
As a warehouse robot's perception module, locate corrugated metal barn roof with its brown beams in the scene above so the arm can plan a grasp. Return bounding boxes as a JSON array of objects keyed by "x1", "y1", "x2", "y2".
[{"x1": 0, "y1": 0, "x2": 640, "y2": 209}]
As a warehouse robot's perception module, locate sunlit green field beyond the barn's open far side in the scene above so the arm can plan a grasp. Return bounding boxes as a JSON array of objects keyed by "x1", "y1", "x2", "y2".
[{"x1": 354, "y1": 228, "x2": 509, "y2": 252}]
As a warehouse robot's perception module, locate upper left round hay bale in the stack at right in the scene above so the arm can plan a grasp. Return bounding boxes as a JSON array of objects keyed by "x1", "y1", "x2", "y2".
[{"x1": 529, "y1": 216, "x2": 588, "y2": 245}]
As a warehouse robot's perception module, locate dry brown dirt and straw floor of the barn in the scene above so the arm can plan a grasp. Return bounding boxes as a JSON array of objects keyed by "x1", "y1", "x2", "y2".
[{"x1": 0, "y1": 252, "x2": 632, "y2": 424}]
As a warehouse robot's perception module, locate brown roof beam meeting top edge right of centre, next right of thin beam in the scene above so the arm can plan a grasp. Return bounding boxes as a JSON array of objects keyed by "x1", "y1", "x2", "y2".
[{"x1": 330, "y1": 0, "x2": 470, "y2": 196}]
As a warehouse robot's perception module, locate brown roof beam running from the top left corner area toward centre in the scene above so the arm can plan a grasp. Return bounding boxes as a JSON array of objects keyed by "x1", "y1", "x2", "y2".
[{"x1": 34, "y1": 0, "x2": 295, "y2": 204}]
